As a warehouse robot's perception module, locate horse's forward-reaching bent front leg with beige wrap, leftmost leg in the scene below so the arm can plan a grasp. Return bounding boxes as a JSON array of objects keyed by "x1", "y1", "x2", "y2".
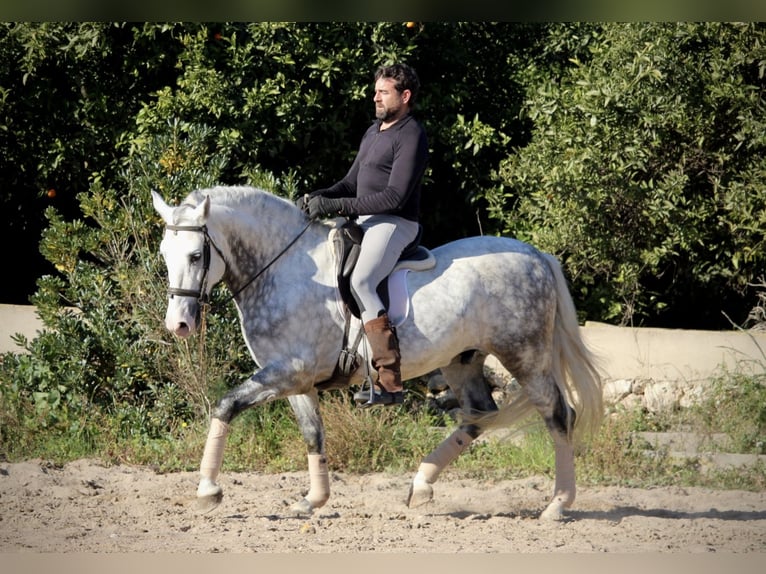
[{"x1": 197, "y1": 366, "x2": 302, "y2": 512}]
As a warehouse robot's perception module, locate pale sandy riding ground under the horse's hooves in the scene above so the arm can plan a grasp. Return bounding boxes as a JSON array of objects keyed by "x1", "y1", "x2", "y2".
[{"x1": 0, "y1": 460, "x2": 766, "y2": 556}]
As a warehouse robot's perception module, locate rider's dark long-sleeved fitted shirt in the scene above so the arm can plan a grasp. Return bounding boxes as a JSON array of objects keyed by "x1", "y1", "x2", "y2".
[{"x1": 320, "y1": 115, "x2": 428, "y2": 221}]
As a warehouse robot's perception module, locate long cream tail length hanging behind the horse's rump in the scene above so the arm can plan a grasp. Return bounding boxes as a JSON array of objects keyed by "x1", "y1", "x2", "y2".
[{"x1": 543, "y1": 253, "x2": 604, "y2": 438}]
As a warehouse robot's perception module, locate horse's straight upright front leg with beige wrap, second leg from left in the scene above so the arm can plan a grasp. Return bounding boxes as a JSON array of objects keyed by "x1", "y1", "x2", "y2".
[{"x1": 288, "y1": 389, "x2": 330, "y2": 513}]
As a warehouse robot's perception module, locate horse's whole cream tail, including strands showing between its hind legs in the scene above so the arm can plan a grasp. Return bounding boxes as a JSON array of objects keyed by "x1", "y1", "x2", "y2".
[{"x1": 463, "y1": 253, "x2": 604, "y2": 446}]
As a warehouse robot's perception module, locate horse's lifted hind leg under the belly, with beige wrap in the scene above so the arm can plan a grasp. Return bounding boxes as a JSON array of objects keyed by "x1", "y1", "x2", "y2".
[{"x1": 407, "y1": 352, "x2": 497, "y2": 508}]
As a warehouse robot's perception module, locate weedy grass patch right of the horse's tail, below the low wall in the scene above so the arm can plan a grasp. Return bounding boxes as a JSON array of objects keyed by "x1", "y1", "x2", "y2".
[{"x1": 578, "y1": 373, "x2": 766, "y2": 491}]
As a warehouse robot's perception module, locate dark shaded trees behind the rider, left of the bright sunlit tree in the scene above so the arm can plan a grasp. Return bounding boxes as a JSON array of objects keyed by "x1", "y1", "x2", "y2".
[{"x1": 0, "y1": 22, "x2": 545, "y2": 303}]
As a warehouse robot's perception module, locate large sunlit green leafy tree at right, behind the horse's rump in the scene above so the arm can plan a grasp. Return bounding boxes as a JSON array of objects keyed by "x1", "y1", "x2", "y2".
[{"x1": 488, "y1": 23, "x2": 766, "y2": 328}]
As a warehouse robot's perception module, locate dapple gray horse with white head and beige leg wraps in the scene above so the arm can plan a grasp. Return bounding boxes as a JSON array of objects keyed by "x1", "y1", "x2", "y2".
[{"x1": 152, "y1": 187, "x2": 603, "y2": 519}]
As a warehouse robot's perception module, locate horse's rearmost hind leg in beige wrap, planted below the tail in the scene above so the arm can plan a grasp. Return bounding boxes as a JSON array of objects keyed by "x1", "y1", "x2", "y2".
[{"x1": 527, "y1": 376, "x2": 576, "y2": 520}]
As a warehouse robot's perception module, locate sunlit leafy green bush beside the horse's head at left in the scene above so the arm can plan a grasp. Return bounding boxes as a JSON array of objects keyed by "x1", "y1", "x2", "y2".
[{"x1": 0, "y1": 112, "x2": 256, "y2": 452}]
